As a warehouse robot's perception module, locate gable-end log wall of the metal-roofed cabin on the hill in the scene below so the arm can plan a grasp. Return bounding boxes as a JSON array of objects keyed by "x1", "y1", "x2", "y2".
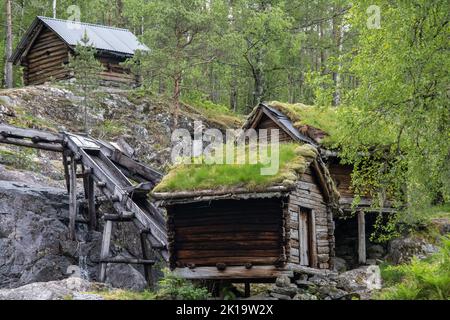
[{"x1": 22, "y1": 27, "x2": 69, "y2": 85}]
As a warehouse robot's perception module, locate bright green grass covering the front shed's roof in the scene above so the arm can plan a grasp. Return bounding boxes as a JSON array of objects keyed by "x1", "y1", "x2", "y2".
[{"x1": 154, "y1": 143, "x2": 317, "y2": 192}]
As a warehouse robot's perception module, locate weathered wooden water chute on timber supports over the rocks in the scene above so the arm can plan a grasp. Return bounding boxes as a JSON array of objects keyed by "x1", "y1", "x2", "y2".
[{"x1": 0, "y1": 124, "x2": 168, "y2": 282}]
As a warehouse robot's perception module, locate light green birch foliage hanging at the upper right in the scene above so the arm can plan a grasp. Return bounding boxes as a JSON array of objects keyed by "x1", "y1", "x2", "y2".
[{"x1": 340, "y1": 0, "x2": 450, "y2": 212}]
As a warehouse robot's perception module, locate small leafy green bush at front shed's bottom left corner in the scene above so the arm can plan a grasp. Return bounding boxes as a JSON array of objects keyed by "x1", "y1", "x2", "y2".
[{"x1": 156, "y1": 269, "x2": 209, "y2": 300}]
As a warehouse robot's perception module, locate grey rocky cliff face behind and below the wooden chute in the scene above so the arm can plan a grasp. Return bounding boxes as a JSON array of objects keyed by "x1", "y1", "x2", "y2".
[{"x1": 0, "y1": 86, "x2": 237, "y2": 290}]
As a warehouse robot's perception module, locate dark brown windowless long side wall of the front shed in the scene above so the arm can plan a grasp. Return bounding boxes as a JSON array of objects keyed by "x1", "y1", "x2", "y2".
[{"x1": 167, "y1": 198, "x2": 287, "y2": 268}]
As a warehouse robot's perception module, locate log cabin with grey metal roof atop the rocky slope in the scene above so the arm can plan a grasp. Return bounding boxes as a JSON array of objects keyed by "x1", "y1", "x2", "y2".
[{"x1": 10, "y1": 17, "x2": 149, "y2": 87}]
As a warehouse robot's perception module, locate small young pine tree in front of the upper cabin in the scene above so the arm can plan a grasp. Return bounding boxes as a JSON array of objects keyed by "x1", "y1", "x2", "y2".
[{"x1": 67, "y1": 32, "x2": 104, "y2": 133}]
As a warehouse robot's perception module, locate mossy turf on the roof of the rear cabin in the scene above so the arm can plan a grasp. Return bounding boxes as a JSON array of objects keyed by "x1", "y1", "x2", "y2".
[{"x1": 269, "y1": 101, "x2": 339, "y2": 145}]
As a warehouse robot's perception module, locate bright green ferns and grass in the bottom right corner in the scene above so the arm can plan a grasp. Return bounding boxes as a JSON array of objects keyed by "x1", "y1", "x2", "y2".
[{"x1": 376, "y1": 238, "x2": 450, "y2": 300}]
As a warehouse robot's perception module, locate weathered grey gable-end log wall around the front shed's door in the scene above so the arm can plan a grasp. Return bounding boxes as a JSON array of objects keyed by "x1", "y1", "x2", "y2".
[{"x1": 288, "y1": 169, "x2": 334, "y2": 269}]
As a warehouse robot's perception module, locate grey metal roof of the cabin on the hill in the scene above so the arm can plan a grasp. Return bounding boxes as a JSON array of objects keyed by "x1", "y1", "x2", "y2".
[{"x1": 11, "y1": 16, "x2": 150, "y2": 62}]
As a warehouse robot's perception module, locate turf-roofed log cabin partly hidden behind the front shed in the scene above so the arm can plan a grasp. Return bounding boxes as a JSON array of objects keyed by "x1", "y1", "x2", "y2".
[{"x1": 243, "y1": 101, "x2": 394, "y2": 267}]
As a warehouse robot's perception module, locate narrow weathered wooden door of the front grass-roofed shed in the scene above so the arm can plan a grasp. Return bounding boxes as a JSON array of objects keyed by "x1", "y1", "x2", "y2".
[{"x1": 298, "y1": 207, "x2": 316, "y2": 267}]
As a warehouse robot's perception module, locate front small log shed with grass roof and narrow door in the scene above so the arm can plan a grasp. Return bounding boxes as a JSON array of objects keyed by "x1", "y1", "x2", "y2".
[{"x1": 152, "y1": 144, "x2": 338, "y2": 281}]
